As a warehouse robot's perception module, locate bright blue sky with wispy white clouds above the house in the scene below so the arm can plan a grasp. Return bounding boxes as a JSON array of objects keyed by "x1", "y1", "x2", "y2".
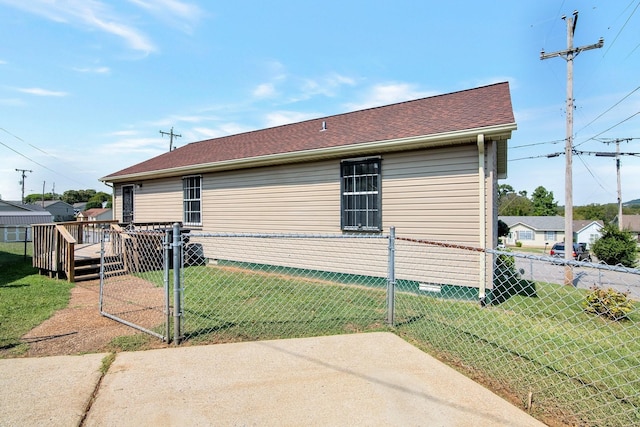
[{"x1": 0, "y1": 0, "x2": 640, "y2": 205}]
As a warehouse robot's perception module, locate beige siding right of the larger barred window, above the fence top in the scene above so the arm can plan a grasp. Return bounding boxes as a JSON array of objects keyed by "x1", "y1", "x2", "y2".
[{"x1": 382, "y1": 146, "x2": 480, "y2": 245}]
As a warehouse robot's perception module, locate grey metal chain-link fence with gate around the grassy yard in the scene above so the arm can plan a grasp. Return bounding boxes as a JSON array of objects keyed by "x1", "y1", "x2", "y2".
[{"x1": 101, "y1": 227, "x2": 640, "y2": 426}]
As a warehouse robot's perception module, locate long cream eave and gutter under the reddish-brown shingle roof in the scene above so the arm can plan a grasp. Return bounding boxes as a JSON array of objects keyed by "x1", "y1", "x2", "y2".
[{"x1": 100, "y1": 122, "x2": 517, "y2": 183}]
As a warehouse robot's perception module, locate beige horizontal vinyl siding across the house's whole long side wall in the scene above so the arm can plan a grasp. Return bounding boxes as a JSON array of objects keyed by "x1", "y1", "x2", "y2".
[{"x1": 116, "y1": 144, "x2": 484, "y2": 286}]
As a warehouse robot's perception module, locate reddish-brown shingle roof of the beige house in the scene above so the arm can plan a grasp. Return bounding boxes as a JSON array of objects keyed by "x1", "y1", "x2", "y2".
[{"x1": 102, "y1": 82, "x2": 515, "y2": 181}]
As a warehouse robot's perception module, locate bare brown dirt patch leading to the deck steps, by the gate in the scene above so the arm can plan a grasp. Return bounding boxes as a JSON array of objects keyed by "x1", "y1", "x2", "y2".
[{"x1": 22, "y1": 280, "x2": 163, "y2": 357}]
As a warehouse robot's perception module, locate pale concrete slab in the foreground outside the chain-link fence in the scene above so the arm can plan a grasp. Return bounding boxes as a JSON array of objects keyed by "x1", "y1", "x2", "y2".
[{"x1": 0, "y1": 333, "x2": 543, "y2": 426}]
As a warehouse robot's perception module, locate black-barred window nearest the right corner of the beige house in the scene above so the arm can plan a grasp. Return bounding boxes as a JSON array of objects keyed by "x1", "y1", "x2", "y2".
[{"x1": 340, "y1": 158, "x2": 382, "y2": 231}]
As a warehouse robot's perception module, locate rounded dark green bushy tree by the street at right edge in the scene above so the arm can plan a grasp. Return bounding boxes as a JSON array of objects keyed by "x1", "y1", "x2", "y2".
[{"x1": 592, "y1": 224, "x2": 638, "y2": 268}]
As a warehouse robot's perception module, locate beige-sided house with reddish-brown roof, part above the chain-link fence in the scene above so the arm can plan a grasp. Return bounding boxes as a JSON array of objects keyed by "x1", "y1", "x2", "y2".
[{"x1": 101, "y1": 83, "x2": 516, "y2": 286}]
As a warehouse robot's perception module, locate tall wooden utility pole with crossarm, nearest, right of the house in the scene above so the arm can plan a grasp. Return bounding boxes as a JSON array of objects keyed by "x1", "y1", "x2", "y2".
[{"x1": 540, "y1": 10, "x2": 604, "y2": 285}]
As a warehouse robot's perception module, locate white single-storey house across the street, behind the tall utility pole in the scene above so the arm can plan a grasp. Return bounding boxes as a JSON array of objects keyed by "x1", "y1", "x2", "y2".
[{"x1": 498, "y1": 215, "x2": 604, "y2": 248}]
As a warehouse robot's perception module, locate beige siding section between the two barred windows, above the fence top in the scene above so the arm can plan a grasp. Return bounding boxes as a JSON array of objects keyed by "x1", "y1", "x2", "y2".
[{"x1": 203, "y1": 161, "x2": 340, "y2": 233}]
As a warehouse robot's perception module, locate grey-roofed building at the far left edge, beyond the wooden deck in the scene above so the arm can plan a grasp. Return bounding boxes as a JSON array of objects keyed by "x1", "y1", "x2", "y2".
[{"x1": 0, "y1": 200, "x2": 53, "y2": 242}]
